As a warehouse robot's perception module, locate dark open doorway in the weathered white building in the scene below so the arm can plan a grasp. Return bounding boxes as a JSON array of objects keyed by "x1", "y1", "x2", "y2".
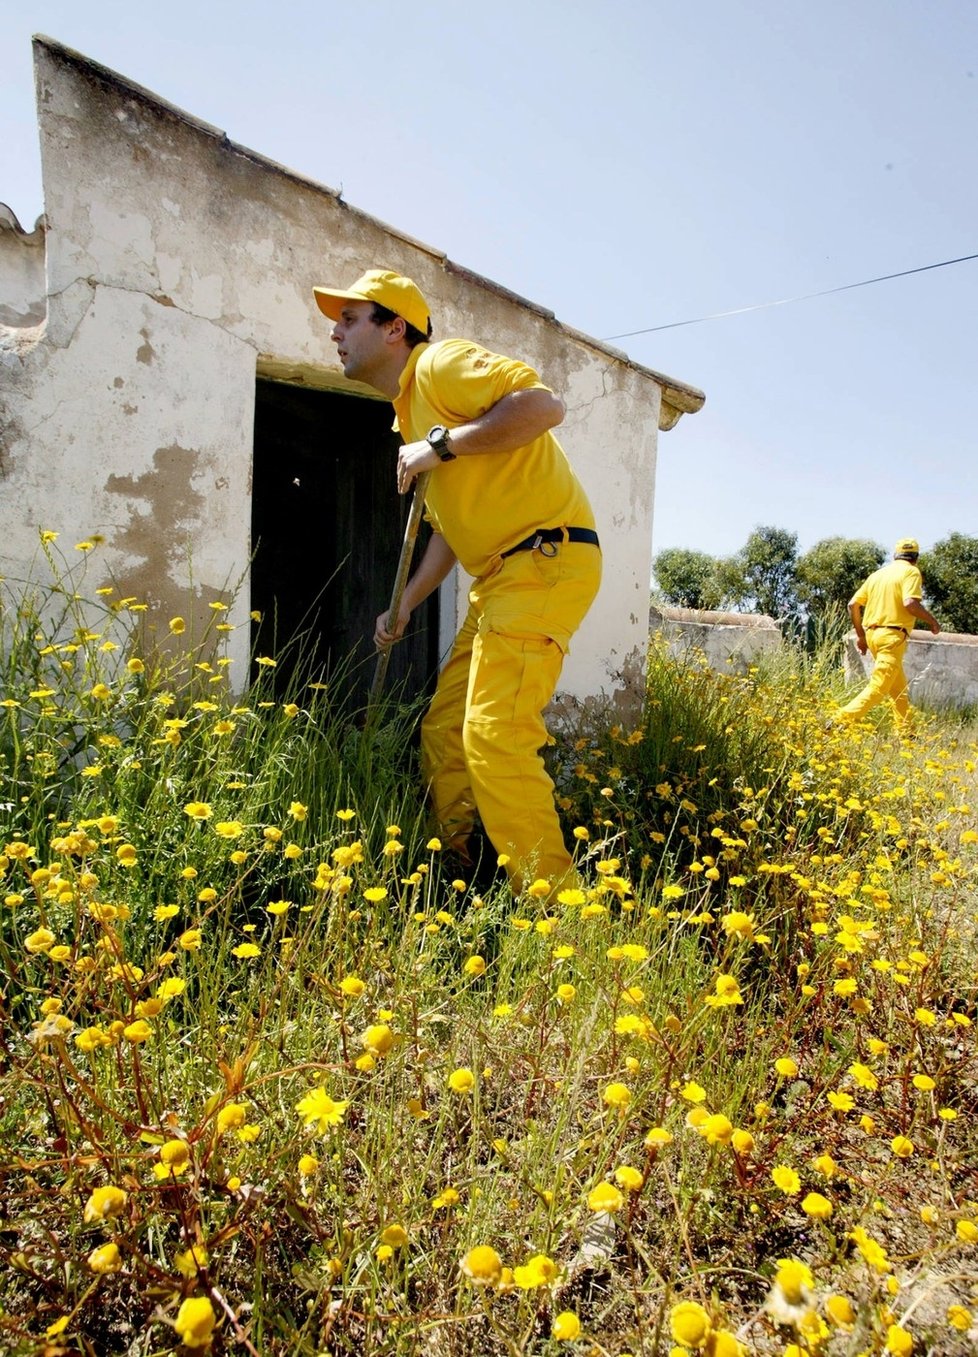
[{"x1": 251, "y1": 379, "x2": 438, "y2": 708}]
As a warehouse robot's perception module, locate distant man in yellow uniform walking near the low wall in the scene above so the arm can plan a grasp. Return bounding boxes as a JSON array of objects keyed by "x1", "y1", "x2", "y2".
[{"x1": 838, "y1": 537, "x2": 940, "y2": 730}]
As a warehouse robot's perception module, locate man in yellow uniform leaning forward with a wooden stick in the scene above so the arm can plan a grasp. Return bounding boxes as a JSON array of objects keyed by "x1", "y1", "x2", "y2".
[{"x1": 313, "y1": 269, "x2": 601, "y2": 890}]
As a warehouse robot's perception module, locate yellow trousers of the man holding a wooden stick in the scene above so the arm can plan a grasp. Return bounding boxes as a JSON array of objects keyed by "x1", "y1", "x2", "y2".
[{"x1": 422, "y1": 543, "x2": 601, "y2": 890}]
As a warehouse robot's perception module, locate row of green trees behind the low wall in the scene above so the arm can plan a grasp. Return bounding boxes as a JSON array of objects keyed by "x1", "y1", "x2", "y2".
[{"x1": 652, "y1": 527, "x2": 978, "y2": 634}]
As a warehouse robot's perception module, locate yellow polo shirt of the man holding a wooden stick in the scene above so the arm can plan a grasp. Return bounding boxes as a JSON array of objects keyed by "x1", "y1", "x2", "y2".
[{"x1": 393, "y1": 339, "x2": 594, "y2": 578}]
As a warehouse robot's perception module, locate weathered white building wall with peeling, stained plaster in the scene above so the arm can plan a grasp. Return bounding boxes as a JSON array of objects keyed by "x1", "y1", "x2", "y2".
[{"x1": 0, "y1": 39, "x2": 703, "y2": 696}]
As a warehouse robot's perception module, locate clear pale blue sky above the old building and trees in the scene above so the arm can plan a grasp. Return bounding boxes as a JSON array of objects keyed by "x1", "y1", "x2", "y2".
[{"x1": 0, "y1": 0, "x2": 978, "y2": 555}]
